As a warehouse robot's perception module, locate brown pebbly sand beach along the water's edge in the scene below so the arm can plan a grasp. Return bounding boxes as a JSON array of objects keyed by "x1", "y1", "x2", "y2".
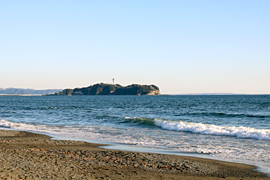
[{"x1": 0, "y1": 130, "x2": 270, "y2": 180}]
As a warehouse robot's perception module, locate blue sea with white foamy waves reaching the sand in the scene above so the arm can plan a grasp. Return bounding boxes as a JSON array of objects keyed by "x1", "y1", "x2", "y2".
[{"x1": 0, "y1": 95, "x2": 270, "y2": 174}]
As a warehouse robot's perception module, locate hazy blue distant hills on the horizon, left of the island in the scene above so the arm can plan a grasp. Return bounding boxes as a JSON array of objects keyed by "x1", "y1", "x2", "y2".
[{"x1": 0, "y1": 88, "x2": 62, "y2": 95}]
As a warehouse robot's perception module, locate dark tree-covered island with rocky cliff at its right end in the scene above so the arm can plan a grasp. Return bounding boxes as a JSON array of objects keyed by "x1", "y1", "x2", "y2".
[{"x1": 52, "y1": 83, "x2": 160, "y2": 95}]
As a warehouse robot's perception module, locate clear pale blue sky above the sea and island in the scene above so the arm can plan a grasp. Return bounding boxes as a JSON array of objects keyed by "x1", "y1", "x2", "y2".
[{"x1": 0, "y1": 0, "x2": 270, "y2": 94}]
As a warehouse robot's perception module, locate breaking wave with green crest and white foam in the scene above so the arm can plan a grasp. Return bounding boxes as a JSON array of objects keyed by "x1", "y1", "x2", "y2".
[{"x1": 125, "y1": 117, "x2": 270, "y2": 140}]
